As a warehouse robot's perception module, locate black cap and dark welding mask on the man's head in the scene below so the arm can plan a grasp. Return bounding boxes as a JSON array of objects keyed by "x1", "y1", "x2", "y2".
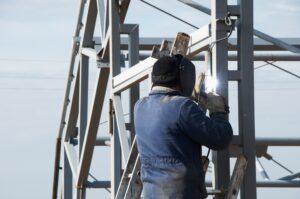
[{"x1": 152, "y1": 54, "x2": 196, "y2": 96}]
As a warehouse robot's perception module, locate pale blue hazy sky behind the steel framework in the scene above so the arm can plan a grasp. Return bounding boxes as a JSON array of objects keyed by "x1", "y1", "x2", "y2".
[{"x1": 0, "y1": 0, "x2": 300, "y2": 199}]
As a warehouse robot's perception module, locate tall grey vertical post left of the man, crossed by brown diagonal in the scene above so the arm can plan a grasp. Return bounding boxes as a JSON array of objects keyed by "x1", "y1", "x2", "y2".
[{"x1": 108, "y1": 0, "x2": 122, "y2": 199}]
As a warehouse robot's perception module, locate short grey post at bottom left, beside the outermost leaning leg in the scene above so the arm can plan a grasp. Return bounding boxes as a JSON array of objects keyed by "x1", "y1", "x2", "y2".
[{"x1": 62, "y1": 149, "x2": 73, "y2": 199}]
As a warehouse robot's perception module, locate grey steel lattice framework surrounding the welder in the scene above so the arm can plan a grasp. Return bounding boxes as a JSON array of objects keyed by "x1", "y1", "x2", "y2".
[{"x1": 53, "y1": 0, "x2": 300, "y2": 199}]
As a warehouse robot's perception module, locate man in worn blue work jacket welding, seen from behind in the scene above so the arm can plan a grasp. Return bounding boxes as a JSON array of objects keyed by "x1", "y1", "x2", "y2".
[{"x1": 134, "y1": 55, "x2": 232, "y2": 199}]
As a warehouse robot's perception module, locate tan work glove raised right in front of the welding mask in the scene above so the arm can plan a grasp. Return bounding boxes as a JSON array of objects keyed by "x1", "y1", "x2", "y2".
[{"x1": 191, "y1": 73, "x2": 207, "y2": 112}]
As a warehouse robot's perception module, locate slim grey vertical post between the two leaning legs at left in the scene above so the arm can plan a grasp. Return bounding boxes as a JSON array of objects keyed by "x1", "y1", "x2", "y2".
[{"x1": 77, "y1": 55, "x2": 89, "y2": 199}]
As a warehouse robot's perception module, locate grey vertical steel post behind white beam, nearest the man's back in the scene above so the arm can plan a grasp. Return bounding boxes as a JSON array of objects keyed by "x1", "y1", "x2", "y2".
[{"x1": 128, "y1": 25, "x2": 140, "y2": 143}]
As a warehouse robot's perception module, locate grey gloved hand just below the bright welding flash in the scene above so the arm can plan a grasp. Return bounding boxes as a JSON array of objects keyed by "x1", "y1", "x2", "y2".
[{"x1": 207, "y1": 93, "x2": 229, "y2": 114}]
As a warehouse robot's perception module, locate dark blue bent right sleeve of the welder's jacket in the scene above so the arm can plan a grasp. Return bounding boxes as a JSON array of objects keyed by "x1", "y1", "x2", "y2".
[{"x1": 179, "y1": 100, "x2": 233, "y2": 150}]
